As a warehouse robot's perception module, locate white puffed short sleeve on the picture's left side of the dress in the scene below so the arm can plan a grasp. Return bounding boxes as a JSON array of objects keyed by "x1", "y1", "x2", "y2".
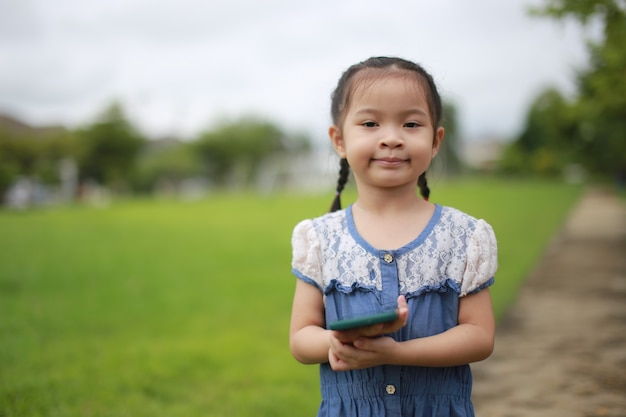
[{"x1": 291, "y1": 220, "x2": 323, "y2": 291}]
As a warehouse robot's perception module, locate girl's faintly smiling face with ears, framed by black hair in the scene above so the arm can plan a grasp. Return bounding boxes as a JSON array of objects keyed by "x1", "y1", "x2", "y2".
[{"x1": 329, "y1": 73, "x2": 444, "y2": 193}]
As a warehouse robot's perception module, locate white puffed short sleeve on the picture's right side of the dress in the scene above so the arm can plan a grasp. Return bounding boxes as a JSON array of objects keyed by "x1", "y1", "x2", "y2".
[{"x1": 460, "y1": 220, "x2": 498, "y2": 297}]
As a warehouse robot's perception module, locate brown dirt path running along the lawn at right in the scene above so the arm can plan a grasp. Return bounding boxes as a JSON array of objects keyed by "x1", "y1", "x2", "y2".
[{"x1": 473, "y1": 189, "x2": 626, "y2": 417}]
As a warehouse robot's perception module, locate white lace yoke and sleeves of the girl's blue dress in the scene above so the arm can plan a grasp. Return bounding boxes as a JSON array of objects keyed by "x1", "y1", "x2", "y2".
[{"x1": 292, "y1": 207, "x2": 497, "y2": 296}]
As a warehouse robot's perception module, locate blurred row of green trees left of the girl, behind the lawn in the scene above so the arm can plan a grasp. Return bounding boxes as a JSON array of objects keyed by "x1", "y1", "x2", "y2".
[{"x1": 0, "y1": 103, "x2": 311, "y2": 202}]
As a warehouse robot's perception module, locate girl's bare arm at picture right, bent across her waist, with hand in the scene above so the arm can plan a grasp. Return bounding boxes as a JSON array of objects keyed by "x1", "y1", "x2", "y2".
[{"x1": 331, "y1": 289, "x2": 495, "y2": 370}]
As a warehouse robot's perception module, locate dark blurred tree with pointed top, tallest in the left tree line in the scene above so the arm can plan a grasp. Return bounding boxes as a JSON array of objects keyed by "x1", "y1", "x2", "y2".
[{"x1": 77, "y1": 103, "x2": 145, "y2": 189}]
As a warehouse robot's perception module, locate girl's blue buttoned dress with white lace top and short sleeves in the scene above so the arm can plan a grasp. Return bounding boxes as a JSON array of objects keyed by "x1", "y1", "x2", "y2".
[{"x1": 292, "y1": 205, "x2": 497, "y2": 417}]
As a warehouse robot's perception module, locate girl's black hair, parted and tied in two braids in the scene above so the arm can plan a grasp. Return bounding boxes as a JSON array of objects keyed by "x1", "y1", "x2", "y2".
[{"x1": 330, "y1": 57, "x2": 443, "y2": 212}]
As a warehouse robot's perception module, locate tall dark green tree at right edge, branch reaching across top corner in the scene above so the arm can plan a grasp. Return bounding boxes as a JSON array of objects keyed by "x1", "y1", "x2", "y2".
[{"x1": 535, "y1": 0, "x2": 626, "y2": 176}]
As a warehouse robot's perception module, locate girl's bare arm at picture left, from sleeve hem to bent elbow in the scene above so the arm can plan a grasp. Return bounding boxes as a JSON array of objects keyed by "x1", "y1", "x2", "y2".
[{"x1": 289, "y1": 279, "x2": 330, "y2": 364}]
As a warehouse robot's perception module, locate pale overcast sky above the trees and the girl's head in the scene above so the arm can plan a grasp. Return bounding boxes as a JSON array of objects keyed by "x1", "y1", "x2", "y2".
[{"x1": 0, "y1": 0, "x2": 589, "y2": 139}]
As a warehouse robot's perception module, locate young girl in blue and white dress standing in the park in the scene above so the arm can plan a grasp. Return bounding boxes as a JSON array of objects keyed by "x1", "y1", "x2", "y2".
[{"x1": 290, "y1": 57, "x2": 497, "y2": 417}]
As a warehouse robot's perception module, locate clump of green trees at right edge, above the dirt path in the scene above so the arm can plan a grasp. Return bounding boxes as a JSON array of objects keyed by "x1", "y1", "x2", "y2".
[{"x1": 500, "y1": 0, "x2": 626, "y2": 181}]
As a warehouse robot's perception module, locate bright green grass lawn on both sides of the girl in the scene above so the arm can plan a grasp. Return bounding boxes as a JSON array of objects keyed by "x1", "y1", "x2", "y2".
[{"x1": 0, "y1": 180, "x2": 580, "y2": 417}]
